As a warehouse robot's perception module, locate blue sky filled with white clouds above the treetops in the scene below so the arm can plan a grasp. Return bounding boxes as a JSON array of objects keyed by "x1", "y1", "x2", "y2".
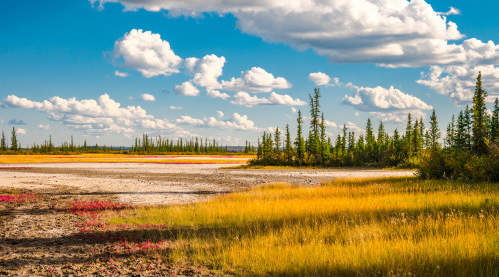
[{"x1": 0, "y1": 0, "x2": 499, "y2": 146}]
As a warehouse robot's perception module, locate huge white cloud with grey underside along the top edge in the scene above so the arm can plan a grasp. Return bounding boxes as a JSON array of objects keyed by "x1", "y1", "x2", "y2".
[{"x1": 95, "y1": 0, "x2": 474, "y2": 66}]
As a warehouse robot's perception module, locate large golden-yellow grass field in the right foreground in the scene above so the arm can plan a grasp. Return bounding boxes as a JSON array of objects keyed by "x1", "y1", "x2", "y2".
[{"x1": 103, "y1": 178, "x2": 499, "y2": 276}]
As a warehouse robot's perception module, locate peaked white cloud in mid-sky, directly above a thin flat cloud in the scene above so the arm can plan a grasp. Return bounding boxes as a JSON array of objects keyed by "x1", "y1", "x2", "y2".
[{"x1": 222, "y1": 67, "x2": 291, "y2": 92}]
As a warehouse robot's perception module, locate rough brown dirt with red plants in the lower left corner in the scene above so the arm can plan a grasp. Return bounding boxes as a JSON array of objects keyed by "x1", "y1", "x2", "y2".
[{"x1": 0, "y1": 186, "x2": 214, "y2": 276}]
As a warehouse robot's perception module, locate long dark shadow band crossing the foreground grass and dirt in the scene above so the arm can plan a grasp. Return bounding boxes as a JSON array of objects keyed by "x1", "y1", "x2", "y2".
[{"x1": 0, "y1": 198, "x2": 499, "y2": 247}]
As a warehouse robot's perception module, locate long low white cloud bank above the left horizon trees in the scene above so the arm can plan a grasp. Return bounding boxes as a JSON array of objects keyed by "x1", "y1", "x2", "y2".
[{"x1": 4, "y1": 94, "x2": 188, "y2": 134}]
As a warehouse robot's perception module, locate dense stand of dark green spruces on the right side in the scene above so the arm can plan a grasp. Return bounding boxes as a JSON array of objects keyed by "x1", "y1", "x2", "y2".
[{"x1": 251, "y1": 73, "x2": 499, "y2": 180}]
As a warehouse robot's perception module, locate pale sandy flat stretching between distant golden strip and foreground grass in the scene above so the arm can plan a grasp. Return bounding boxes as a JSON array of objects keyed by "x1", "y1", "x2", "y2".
[{"x1": 0, "y1": 161, "x2": 414, "y2": 205}]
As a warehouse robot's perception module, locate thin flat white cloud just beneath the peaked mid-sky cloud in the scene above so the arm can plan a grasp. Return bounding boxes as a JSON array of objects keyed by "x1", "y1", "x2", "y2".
[{"x1": 231, "y1": 91, "x2": 306, "y2": 107}]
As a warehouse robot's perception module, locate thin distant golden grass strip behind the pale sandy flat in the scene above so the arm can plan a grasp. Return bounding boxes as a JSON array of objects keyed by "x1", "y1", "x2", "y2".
[{"x1": 0, "y1": 154, "x2": 252, "y2": 164}]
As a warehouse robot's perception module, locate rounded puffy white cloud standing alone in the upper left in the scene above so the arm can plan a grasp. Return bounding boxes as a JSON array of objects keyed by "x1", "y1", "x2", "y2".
[{"x1": 114, "y1": 29, "x2": 182, "y2": 78}]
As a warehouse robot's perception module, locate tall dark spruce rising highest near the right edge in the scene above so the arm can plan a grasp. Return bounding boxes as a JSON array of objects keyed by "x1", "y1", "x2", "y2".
[{"x1": 472, "y1": 72, "x2": 487, "y2": 155}]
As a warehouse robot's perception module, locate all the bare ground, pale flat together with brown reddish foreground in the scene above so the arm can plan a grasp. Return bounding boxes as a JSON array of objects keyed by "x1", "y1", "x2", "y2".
[{"x1": 0, "y1": 160, "x2": 413, "y2": 276}]
